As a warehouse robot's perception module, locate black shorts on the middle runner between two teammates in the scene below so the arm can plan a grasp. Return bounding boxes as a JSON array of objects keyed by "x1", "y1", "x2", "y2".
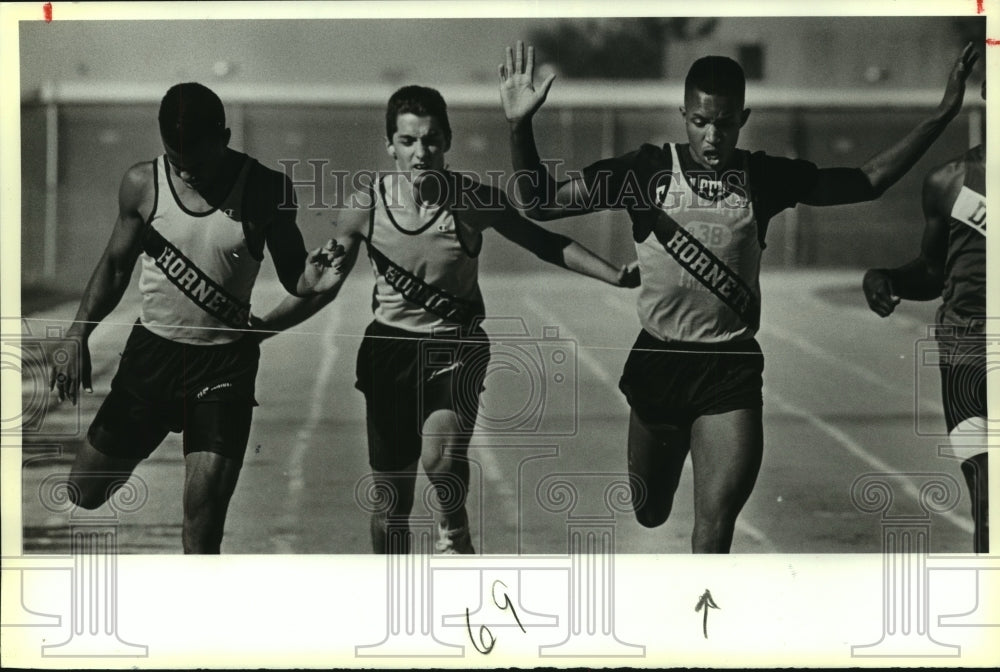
[{"x1": 356, "y1": 322, "x2": 490, "y2": 471}]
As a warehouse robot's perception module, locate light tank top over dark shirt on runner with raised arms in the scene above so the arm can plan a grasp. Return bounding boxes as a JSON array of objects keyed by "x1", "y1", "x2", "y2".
[{"x1": 635, "y1": 144, "x2": 762, "y2": 343}]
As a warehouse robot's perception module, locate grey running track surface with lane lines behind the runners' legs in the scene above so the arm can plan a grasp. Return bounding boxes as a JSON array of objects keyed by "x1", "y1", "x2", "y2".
[{"x1": 11, "y1": 270, "x2": 972, "y2": 554}]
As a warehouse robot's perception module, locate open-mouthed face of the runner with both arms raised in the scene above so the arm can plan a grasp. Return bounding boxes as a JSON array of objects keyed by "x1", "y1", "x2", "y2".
[{"x1": 681, "y1": 89, "x2": 750, "y2": 170}]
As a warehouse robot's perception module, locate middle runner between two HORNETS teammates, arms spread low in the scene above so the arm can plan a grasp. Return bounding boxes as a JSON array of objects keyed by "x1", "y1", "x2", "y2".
[{"x1": 259, "y1": 86, "x2": 638, "y2": 553}]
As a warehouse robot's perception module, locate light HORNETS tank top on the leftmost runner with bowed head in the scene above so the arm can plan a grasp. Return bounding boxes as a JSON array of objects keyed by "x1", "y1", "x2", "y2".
[{"x1": 139, "y1": 155, "x2": 261, "y2": 345}]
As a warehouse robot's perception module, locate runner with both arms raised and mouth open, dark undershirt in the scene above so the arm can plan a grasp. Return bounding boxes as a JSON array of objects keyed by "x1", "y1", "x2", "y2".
[{"x1": 500, "y1": 42, "x2": 977, "y2": 553}]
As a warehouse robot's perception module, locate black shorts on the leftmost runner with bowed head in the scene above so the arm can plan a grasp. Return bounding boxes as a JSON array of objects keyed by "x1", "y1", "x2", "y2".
[{"x1": 87, "y1": 323, "x2": 260, "y2": 459}]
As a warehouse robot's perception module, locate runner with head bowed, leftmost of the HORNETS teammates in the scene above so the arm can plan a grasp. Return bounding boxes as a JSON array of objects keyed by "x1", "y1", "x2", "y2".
[{"x1": 52, "y1": 83, "x2": 342, "y2": 553}]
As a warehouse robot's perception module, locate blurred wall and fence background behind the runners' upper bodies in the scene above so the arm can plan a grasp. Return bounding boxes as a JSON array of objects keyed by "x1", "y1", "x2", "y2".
[{"x1": 20, "y1": 17, "x2": 985, "y2": 292}]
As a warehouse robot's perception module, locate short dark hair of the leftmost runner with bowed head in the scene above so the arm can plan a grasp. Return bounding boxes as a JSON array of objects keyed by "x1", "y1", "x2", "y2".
[{"x1": 159, "y1": 82, "x2": 226, "y2": 151}]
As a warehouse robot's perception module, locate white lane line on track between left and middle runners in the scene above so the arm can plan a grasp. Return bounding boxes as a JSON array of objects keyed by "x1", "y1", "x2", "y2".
[{"x1": 274, "y1": 301, "x2": 341, "y2": 553}]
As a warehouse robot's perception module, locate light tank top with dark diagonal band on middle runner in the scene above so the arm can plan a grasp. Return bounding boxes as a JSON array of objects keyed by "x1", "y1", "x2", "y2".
[{"x1": 366, "y1": 175, "x2": 484, "y2": 333}]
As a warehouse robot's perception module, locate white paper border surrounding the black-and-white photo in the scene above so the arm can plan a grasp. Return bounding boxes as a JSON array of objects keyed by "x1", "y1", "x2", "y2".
[{"x1": 0, "y1": 0, "x2": 1000, "y2": 668}]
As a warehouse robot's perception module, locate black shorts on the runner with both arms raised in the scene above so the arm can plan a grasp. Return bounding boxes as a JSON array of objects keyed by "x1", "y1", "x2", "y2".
[{"x1": 618, "y1": 330, "x2": 764, "y2": 427}]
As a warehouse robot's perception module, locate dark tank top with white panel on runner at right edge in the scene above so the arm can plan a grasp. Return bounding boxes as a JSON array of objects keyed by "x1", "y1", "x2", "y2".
[{"x1": 938, "y1": 146, "x2": 986, "y2": 326}]
